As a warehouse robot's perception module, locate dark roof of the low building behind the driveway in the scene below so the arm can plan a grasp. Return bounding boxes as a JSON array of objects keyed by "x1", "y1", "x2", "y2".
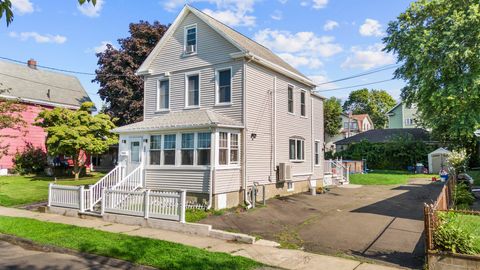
[{"x1": 335, "y1": 128, "x2": 430, "y2": 145}]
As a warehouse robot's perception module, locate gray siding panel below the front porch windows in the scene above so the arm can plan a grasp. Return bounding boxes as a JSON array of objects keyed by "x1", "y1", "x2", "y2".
[{"x1": 145, "y1": 168, "x2": 210, "y2": 193}]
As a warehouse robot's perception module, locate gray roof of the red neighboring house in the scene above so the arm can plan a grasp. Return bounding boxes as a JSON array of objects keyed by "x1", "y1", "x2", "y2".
[{"x1": 0, "y1": 60, "x2": 91, "y2": 109}]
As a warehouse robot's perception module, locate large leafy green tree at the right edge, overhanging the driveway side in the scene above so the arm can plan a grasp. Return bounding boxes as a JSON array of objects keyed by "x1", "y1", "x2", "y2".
[{"x1": 384, "y1": 0, "x2": 480, "y2": 149}]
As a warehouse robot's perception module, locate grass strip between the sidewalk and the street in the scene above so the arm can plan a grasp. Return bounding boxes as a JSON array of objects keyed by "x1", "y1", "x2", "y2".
[{"x1": 0, "y1": 216, "x2": 261, "y2": 269}]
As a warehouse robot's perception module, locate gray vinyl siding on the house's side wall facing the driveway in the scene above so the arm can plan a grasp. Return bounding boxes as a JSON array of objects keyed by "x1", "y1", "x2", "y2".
[{"x1": 246, "y1": 63, "x2": 323, "y2": 185}]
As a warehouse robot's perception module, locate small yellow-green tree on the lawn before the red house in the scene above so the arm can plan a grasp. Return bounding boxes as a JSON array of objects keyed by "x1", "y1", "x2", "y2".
[{"x1": 36, "y1": 102, "x2": 117, "y2": 179}]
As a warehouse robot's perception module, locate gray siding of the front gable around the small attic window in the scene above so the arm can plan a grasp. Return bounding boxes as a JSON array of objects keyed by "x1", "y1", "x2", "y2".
[{"x1": 148, "y1": 13, "x2": 240, "y2": 74}]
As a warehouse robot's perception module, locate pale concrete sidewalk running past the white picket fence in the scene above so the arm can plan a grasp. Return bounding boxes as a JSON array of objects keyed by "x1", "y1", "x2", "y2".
[{"x1": 0, "y1": 207, "x2": 397, "y2": 270}]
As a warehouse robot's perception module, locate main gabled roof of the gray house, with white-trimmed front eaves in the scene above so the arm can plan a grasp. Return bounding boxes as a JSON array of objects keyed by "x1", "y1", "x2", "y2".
[{"x1": 137, "y1": 5, "x2": 315, "y2": 86}]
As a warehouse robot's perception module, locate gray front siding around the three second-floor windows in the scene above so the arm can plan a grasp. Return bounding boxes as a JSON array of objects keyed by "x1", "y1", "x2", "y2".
[{"x1": 144, "y1": 60, "x2": 244, "y2": 123}]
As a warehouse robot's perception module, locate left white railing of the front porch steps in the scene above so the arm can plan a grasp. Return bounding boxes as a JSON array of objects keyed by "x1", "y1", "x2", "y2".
[{"x1": 86, "y1": 165, "x2": 125, "y2": 211}]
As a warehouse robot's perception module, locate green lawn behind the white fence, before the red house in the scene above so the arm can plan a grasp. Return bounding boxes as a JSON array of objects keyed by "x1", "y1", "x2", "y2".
[{"x1": 0, "y1": 173, "x2": 104, "y2": 206}]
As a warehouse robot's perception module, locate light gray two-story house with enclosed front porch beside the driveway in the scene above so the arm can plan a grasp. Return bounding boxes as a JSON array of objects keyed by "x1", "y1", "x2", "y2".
[{"x1": 110, "y1": 5, "x2": 324, "y2": 209}]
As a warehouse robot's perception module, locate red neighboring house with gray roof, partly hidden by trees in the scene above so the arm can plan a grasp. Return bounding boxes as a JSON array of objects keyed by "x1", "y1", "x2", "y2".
[{"x1": 0, "y1": 59, "x2": 91, "y2": 174}]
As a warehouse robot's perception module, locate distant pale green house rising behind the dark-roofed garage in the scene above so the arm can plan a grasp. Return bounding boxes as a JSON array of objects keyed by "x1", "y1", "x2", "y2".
[{"x1": 387, "y1": 102, "x2": 418, "y2": 128}]
